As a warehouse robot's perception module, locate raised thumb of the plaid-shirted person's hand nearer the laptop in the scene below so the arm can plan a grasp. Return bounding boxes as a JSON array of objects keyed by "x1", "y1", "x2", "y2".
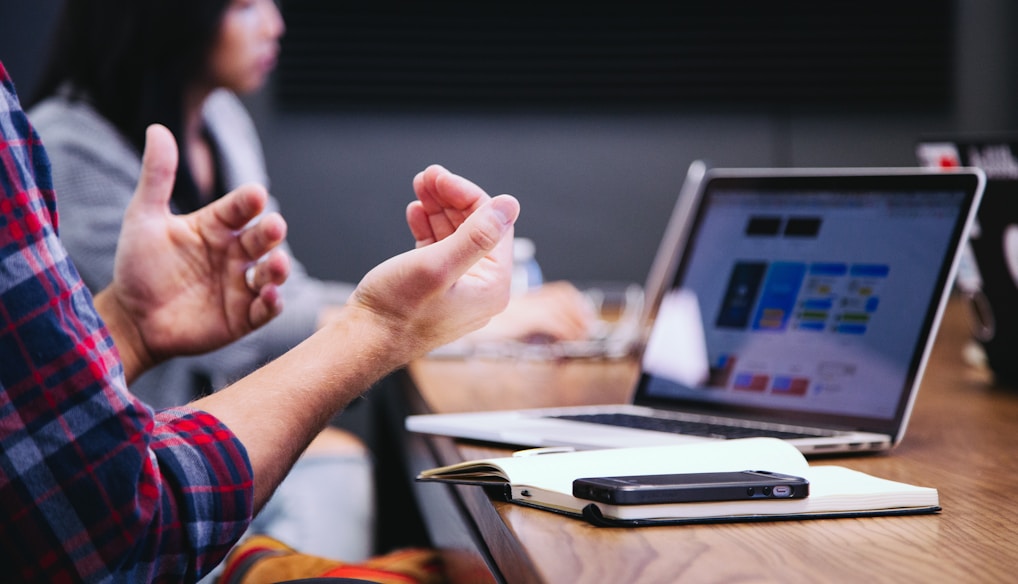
[{"x1": 433, "y1": 194, "x2": 519, "y2": 277}]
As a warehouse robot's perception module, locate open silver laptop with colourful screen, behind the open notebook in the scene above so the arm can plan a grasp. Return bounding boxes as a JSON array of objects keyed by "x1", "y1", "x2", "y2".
[{"x1": 406, "y1": 169, "x2": 984, "y2": 454}]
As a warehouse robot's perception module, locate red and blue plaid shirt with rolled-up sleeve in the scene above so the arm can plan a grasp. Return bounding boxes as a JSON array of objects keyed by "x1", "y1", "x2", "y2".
[{"x1": 0, "y1": 63, "x2": 252, "y2": 582}]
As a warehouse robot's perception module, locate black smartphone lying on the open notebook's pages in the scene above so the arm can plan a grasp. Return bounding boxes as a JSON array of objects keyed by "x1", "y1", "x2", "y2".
[{"x1": 573, "y1": 470, "x2": 809, "y2": 505}]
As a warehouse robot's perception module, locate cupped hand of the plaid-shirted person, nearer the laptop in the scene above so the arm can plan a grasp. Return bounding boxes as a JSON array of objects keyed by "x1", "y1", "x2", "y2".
[{"x1": 347, "y1": 166, "x2": 519, "y2": 366}]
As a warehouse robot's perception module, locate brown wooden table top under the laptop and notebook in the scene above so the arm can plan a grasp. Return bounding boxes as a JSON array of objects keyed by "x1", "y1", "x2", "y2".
[{"x1": 394, "y1": 299, "x2": 1018, "y2": 584}]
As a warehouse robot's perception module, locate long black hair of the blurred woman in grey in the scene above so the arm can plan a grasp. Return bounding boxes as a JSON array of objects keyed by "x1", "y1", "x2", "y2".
[{"x1": 30, "y1": 0, "x2": 230, "y2": 211}]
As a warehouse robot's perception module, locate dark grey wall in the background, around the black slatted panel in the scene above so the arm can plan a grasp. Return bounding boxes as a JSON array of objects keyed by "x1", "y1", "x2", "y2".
[{"x1": 0, "y1": 0, "x2": 1018, "y2": 288}]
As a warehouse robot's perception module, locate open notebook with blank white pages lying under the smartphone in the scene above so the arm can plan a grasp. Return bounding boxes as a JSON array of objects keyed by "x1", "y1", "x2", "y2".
[{"x1": 417, "y1": 439, "x2": 941, "y2": 526}]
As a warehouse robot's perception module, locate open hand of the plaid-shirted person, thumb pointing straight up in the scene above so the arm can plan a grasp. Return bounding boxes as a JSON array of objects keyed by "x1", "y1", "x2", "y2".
[{"x1": 96, "y1": 125, "x2": 290, "y2": 379}]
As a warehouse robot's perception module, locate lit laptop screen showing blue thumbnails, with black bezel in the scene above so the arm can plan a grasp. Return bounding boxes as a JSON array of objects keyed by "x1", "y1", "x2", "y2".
[{"x1": 635, "y1": 170, "x2": 979, "y2": 433}]
